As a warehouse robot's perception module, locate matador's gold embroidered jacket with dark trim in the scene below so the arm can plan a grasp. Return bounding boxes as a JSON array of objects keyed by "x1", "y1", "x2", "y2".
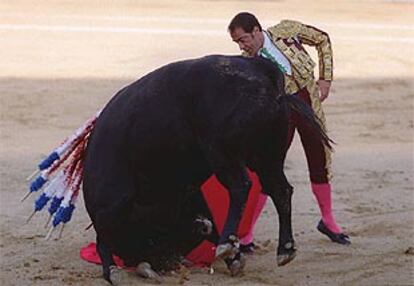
[{"x1": 267, "y1": 20, "x2": 333, "y2": 93}]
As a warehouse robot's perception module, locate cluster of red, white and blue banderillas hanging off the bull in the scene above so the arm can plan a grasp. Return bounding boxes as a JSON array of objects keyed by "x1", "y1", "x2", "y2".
[{"x1": 24, "y1": 109, "x2": 100, "y2": 238}]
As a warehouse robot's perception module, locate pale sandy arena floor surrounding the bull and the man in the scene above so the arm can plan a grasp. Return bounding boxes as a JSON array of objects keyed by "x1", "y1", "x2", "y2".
[{"x1": 0, "y1": 0, "x2": 414, "y2": 286}]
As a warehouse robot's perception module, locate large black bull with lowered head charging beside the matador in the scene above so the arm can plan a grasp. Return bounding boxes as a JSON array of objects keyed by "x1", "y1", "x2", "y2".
[{"x1": 83, "y1": 56, "x2": 329, "y2": 280}]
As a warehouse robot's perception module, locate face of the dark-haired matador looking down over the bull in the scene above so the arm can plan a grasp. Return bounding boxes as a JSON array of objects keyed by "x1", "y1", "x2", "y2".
[{"x1": 230, "y1": 26, "x2": 263, "y2": 57}]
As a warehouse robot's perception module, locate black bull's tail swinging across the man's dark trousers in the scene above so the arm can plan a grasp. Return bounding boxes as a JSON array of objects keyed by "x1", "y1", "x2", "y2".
[{"x1": 281, "y1": 95, "x2": 335, "y2": 150}]
